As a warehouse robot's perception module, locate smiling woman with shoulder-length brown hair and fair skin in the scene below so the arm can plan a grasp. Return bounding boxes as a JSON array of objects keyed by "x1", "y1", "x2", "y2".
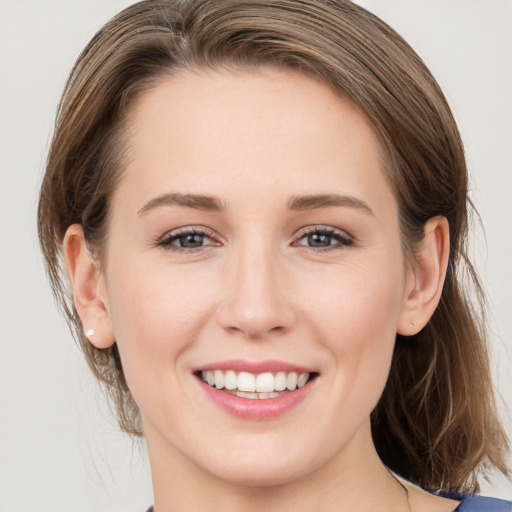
[{"x1": 39, "y1": 0, "x2": 510, "y2": 512}]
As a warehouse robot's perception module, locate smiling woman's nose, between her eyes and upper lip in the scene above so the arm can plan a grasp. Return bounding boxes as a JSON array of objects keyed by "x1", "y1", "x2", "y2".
[{"x1": 217, "y1": 246, "x2": 296, "y2": 340}]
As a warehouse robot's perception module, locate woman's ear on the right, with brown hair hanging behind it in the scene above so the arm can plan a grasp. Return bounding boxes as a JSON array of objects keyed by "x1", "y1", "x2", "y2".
[{"x1": 397, "y1": 216, "x2": 450, "y2": 336}]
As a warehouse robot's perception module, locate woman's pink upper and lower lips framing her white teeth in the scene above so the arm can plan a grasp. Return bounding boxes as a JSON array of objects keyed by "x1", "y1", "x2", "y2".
[{"x1": 194, "y1": 360, "x2": 317, "y2": 420}]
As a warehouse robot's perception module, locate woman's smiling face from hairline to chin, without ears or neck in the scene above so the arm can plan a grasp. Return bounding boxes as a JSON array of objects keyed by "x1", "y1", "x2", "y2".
[{"x1": 99, "y1": 69, "x2": 410, "y2": 485}]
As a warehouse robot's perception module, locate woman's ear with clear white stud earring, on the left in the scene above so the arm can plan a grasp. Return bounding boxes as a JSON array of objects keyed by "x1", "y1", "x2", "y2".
[{"x1": 63, "y1": 224, "x2": 115, "y2": 348}]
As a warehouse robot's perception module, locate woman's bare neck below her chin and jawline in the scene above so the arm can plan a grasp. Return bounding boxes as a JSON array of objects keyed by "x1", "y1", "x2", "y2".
[{"x1": 146, "y1": 425, "x2": 408, "y2": 512}]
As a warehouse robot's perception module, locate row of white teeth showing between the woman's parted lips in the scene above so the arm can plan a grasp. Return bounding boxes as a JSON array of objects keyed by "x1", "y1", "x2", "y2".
[{"x1": 195, "y1": 370, "x2": 318, "y2": 400}]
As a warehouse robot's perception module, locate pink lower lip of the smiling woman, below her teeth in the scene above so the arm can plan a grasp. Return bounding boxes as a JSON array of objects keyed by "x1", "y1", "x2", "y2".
[{"x1": 197, "y1": 378, "x2": 316, "y2": 420}]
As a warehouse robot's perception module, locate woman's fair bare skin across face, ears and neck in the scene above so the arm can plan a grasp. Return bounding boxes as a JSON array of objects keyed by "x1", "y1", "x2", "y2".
[{"x1": 64, "y1": 68, "x2": 457, "y2": 512}]
